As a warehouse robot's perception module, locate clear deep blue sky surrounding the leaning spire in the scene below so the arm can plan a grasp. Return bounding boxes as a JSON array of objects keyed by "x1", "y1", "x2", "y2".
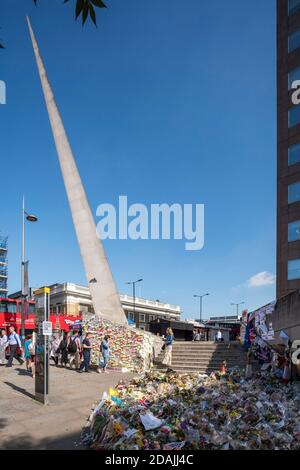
[{"x1": 0, "y1": 0, "x2": 276, "y2": 317}]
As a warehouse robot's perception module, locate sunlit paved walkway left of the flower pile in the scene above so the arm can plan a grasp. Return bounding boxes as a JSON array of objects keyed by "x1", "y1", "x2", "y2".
[{"x1": 0, "y1": 364, "x2": 132, "y2": 450}]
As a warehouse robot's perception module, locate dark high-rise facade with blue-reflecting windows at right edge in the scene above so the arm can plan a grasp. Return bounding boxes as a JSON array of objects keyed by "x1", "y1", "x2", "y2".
[{"x1": 277, "y1": 0, "x2": 300, "y2": 299}]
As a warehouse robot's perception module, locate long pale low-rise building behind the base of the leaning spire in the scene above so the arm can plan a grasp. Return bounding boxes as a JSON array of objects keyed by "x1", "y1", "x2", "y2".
[{"x1": 44, "y1": 282, "x2": 180, "y2": 331}]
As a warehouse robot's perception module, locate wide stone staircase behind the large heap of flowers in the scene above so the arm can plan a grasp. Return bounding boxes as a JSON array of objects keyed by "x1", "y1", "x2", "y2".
[{"x1": 154, "y1": 341, "x2": 247, "y2": 374}]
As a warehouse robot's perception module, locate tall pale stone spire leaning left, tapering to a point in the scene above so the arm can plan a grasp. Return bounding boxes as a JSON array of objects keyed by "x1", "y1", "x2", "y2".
[{"x1": 27, "y1": 17, "x2": 126, "y2": 324}]
